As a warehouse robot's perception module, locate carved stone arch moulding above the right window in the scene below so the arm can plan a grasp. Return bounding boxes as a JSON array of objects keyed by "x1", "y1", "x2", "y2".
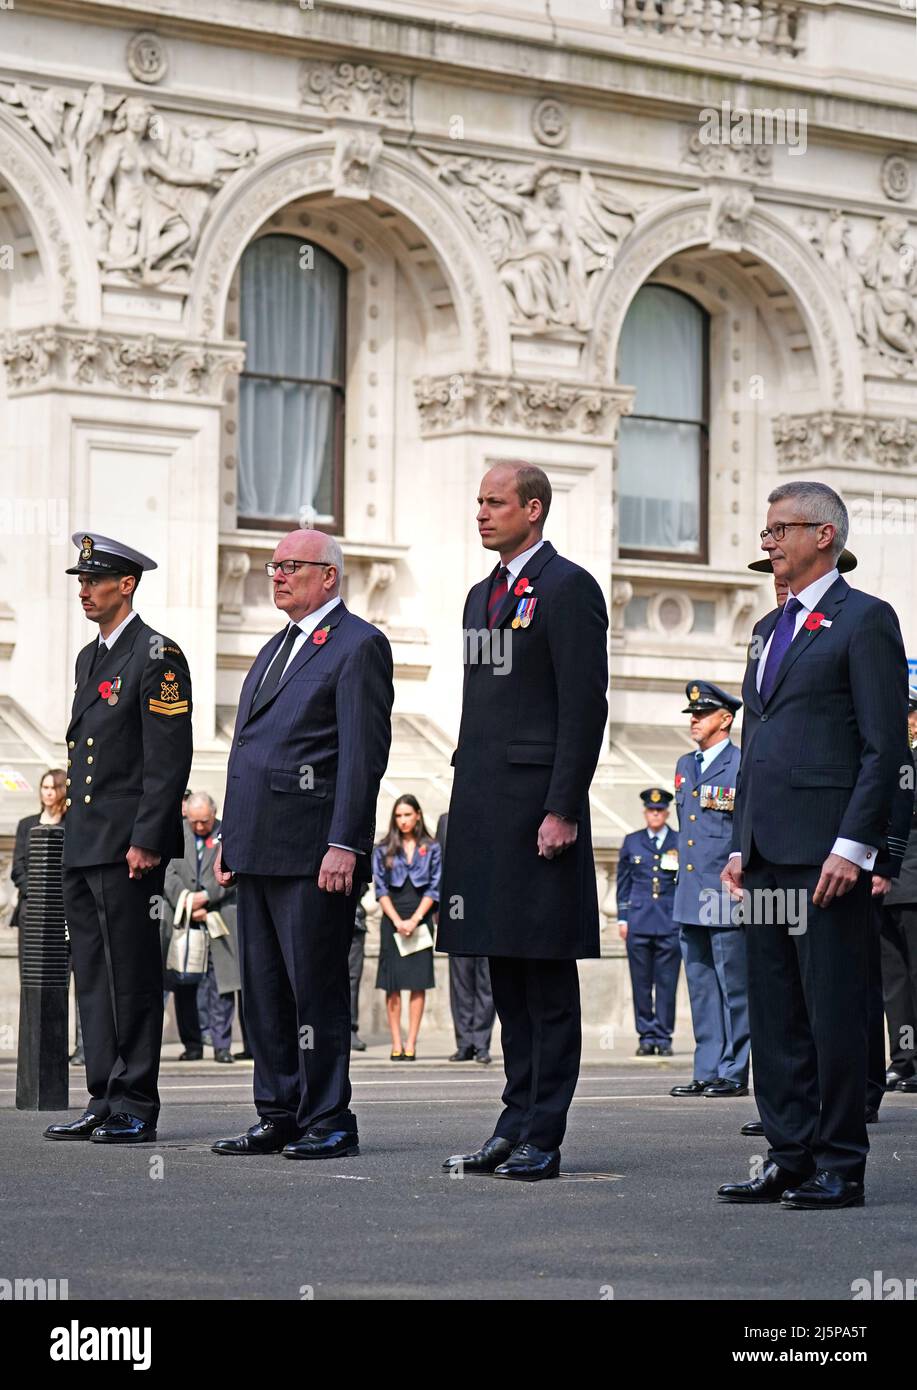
[{"x1": 586, "y1": 190, "x2": 863, "y2": 410}]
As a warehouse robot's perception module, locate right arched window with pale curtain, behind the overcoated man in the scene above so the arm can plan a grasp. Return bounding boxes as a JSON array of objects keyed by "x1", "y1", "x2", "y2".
[{"x1": 618, "y1": 285, "x2": 709, "y2": 563}]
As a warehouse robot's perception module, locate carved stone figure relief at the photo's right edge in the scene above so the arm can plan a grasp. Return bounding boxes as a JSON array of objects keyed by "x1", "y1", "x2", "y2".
[{"x1": 800, "y1": 209, "x2": 917, "y2": 377}]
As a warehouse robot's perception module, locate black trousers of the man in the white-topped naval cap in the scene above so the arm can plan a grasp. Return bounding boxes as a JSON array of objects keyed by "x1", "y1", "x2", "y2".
[{"x1": 64, "y1": 860, "x2": 165, "y2": 1120}]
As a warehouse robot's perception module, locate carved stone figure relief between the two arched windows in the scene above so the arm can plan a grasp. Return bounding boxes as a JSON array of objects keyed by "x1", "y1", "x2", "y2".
[{"x1": 420, "y1": 150, "x2": 635, "y2": 332}]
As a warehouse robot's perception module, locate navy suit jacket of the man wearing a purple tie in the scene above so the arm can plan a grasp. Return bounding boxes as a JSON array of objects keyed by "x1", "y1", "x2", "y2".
[{"x1": 732, "y1": 575, "x2": 907, "y2": 865}]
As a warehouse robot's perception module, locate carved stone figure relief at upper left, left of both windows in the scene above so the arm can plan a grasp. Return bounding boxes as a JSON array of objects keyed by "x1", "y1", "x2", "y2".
[{"x1": 0, "y1": 82, "x2": 257, "y2": 288}]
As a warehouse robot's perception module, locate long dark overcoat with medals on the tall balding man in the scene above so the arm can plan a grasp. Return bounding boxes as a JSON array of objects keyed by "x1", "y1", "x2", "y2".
[{"x1": 438, "y1": 541, "x2": 609, "y2": 960}]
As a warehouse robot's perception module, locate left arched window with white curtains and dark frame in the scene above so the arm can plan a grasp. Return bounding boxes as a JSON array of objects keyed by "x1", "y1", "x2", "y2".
[{"x1": 239, "y1": 236, "x2": 347, "y2": 531}]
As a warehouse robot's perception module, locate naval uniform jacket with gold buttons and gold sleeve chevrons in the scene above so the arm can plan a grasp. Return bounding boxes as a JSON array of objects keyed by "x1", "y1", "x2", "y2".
[{"x1": 64, "y1": 616, "x2": 193, "y2": 867}]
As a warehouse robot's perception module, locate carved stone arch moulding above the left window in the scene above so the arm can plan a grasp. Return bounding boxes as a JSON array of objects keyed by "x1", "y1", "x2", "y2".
[{"x1": 188, "y1": 136, "x2": 511, "y2": 371}]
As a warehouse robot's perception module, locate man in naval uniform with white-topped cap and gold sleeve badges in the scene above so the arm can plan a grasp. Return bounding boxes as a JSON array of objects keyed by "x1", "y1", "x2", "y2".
[{"x1": 44, "y1": 531, "x2": 192, "y2": 1144}]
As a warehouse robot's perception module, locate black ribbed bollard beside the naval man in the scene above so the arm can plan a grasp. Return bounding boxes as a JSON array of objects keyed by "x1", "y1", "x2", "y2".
[{"x1": 15, "y1": 826, "x2": 69, "y2": 1111}]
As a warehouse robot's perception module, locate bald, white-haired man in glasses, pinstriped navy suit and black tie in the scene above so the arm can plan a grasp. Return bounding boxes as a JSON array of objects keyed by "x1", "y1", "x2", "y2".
[{"x1": 213, "y1": 531, "x2": 393, "y2": 1159}]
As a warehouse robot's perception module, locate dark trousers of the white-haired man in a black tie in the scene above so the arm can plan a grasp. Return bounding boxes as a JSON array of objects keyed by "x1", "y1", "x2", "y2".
[{"x1": 238, "y1": 874, "x2": 357, "y2": 1134}]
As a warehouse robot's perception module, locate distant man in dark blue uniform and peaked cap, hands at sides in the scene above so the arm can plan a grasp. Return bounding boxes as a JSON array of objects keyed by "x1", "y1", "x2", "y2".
[{"x1": 617, "y1": 787, "x2": 681, "y2": 1056}]
